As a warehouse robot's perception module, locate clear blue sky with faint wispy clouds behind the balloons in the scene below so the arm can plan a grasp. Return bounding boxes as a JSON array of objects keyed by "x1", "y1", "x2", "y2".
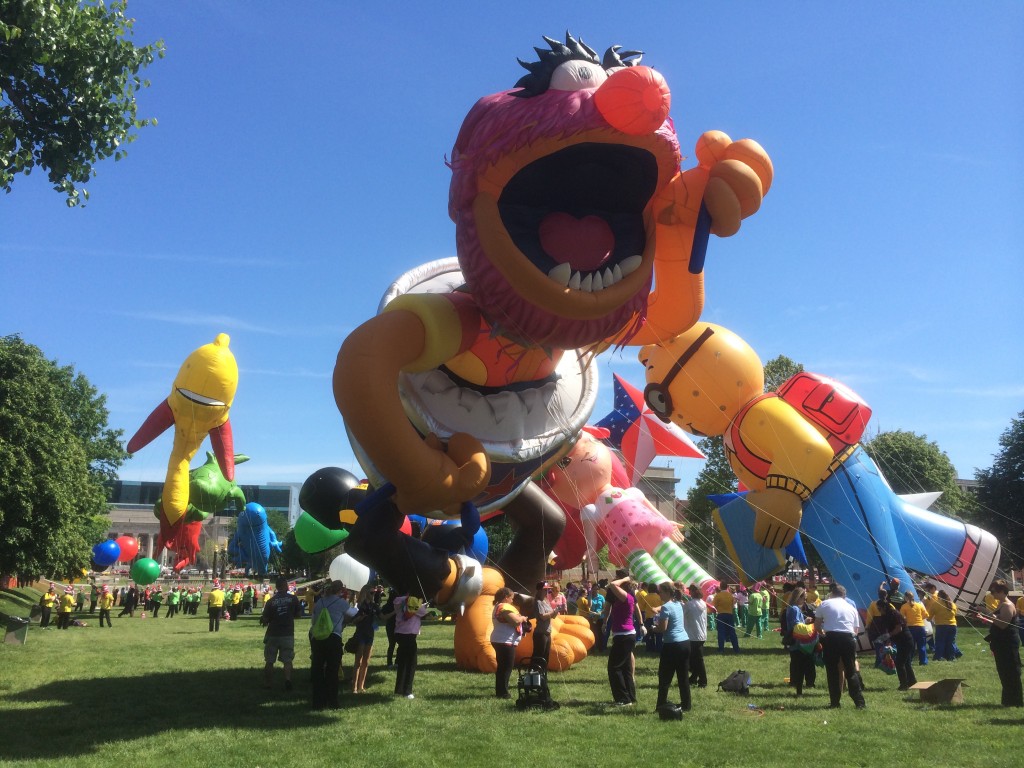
[{"x1": 0, "y1": 0, "x2": 1024, "y2": 494}]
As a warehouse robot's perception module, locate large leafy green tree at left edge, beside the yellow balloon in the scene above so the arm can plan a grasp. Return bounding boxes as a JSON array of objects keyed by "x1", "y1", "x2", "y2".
[{"x1": 0, "y1": 336, "x2": 127, "y2": 577}]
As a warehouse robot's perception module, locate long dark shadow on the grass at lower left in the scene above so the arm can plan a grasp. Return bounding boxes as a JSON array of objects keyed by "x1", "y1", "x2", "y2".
[{"x1": 0, "y1": 671, "x2": 337, "y2": 760}]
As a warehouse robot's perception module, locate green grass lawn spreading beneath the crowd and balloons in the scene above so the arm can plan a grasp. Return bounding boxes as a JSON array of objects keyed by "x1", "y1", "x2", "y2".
[{"x1": 0, "y1": 593, "x2": 1024, "y2": 768}]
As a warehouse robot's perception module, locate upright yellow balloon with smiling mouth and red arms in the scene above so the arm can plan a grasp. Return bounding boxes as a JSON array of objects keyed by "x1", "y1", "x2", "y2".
[{"x1": 127, "y1": 334, "x2": 239, "y2": 570}]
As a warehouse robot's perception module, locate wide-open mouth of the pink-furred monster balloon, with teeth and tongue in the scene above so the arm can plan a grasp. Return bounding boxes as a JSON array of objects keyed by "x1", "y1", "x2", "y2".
[{"x1": 498, "y1": 142, "x2": 657, "y2": 292}]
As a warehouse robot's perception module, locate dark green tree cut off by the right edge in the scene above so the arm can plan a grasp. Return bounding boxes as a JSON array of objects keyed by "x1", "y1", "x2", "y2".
[{"x1": 975, "y1": 411, "x2": 1024, "y2": 568}]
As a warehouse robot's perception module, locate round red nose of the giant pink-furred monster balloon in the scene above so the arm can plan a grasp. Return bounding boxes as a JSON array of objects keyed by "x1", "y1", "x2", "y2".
[{"x1": 594, "y1": 67, "x2": 672, "y2": 136}]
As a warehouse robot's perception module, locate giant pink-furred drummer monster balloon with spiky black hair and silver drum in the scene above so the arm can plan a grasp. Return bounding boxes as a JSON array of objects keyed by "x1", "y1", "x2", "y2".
[{"x1": 334, "y1": 35, "x2": 772, "y2": 626}]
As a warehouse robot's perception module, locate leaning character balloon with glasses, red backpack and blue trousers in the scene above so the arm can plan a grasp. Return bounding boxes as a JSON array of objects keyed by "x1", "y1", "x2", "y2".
[{"x1": 640, "y1": 323, "x2": 999, "y2": 609}]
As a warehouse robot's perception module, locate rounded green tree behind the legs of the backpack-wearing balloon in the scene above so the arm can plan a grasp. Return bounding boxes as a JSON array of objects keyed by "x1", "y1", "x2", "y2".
[{"x1": 863, "y1": 430, "x2": 975, "y2": 518}]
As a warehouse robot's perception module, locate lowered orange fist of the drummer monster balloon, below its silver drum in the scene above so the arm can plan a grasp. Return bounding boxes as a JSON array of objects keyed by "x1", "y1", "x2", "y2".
[{"x1": 394, "y1": 432, "x2": 490, "y2": 516}]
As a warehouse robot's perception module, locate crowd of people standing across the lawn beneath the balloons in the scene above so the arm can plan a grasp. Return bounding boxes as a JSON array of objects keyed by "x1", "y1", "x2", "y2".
[{"x1": 28, "y1": 570, "x2": 1024, "y2": 713}]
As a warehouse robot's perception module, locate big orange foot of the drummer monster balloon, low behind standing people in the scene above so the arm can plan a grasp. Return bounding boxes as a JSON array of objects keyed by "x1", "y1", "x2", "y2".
[{"x1": 455, "y1": 568, "x2": 595, "y2": 673}]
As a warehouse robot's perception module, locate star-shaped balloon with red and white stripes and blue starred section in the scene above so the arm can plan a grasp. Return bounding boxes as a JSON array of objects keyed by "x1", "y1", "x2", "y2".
[{"x1": 596, "y1": 374, "x2": 705, "y2": 485}]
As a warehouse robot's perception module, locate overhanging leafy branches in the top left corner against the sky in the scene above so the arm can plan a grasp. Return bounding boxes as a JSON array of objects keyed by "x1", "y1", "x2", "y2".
[{"x1": 0, "y1": 0, "x2": 164, "y2": 207}]
